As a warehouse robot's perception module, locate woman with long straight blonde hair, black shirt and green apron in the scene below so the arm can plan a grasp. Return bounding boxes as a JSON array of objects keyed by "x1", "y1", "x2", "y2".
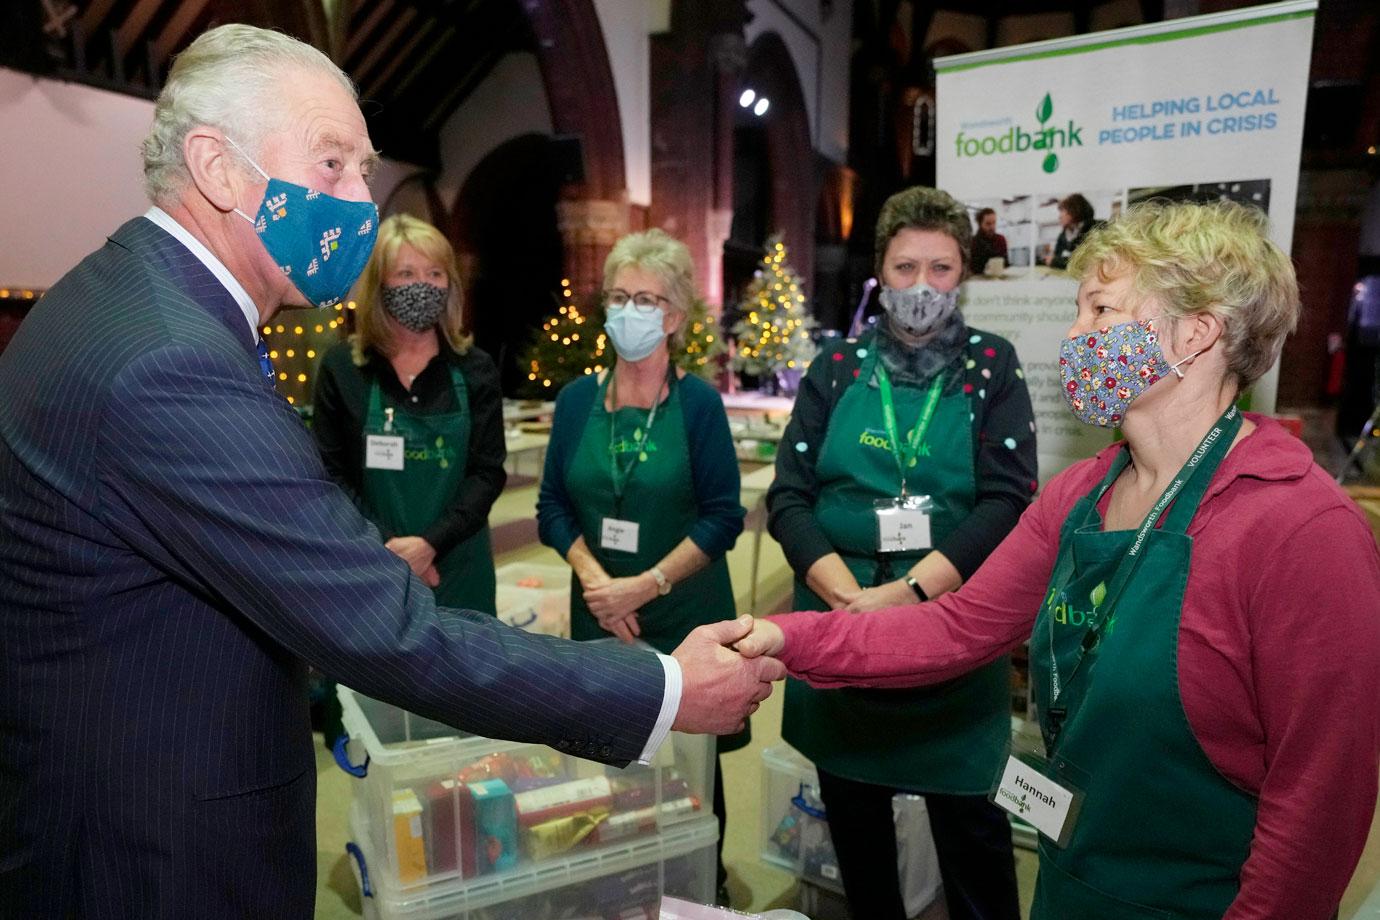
[{"x1": 312, "y1": 214, "x2": 505, "y2": 614}]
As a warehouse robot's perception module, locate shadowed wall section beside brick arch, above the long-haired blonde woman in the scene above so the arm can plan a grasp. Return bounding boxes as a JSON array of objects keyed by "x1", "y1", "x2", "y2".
[{"x1": 436, "y1": 52, "x2": 553, "y2": 208}]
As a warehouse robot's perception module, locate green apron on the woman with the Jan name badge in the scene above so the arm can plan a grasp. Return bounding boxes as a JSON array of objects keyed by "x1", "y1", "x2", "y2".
[{"x1": 781, "y1": 348, "x2": 1012, "y2": 794}]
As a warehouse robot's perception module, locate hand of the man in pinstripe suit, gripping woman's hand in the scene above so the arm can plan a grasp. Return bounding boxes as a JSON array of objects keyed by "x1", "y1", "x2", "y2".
[{"x1": 671, "y1": 615, "x2": 785, "y2": 735}]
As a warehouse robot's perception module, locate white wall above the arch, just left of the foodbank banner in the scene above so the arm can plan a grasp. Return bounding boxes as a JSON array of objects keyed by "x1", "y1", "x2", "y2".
[{"x1": 747, "y1": 0, "x2": 853, "y2": 163}]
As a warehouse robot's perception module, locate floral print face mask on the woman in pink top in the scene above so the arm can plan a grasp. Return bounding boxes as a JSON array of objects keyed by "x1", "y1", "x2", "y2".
[{"x1": 1058, "y1": 317, "x2": 1198, "y2": 428}]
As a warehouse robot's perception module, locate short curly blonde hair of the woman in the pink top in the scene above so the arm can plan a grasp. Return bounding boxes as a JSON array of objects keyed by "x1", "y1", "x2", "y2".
[{"x1": 1068, "y1": 200, "x2": 1300, "y2": 388}]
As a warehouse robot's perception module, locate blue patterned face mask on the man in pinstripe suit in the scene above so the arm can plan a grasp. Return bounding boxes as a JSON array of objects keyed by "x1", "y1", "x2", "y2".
[{"x1": 225, "y1": 138, "x2": 378, "y2": 306}]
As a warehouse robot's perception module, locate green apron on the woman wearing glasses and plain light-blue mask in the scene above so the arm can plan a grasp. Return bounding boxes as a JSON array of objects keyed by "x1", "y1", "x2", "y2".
[{"x1": 566, "y1": 368, "x2": 751, "y2": 752}]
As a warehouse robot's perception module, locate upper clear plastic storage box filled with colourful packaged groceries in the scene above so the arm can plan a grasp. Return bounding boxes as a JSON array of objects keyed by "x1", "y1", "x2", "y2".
[{"x1": 337, "y1": 687, "x2": 715, "y2": 891}]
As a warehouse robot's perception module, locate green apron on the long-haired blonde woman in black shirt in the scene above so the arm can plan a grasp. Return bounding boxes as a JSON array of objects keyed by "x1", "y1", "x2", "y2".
[{"x1": 362, "y1": 366, "x2": 497, "y2": 614}]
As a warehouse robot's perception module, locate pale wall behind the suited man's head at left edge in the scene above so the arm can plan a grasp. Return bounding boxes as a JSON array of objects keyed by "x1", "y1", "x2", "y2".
[{"x1": 0, "y1": 68, "x2": 153, "y2": 288}]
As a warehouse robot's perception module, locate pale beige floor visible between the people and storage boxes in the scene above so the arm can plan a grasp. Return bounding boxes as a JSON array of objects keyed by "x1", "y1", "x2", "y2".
[{"x1": 316, "y1": 455, "x2": 1380, "y2": 920}]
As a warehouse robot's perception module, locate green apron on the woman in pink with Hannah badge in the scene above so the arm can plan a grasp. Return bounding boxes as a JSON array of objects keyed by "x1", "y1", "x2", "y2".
[{"x1": 1031, "y1": 411, "x2": 1256, "y2": 920}]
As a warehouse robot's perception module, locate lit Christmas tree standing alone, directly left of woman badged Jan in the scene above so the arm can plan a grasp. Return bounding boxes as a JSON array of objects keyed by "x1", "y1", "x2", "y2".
[{"x1": 733, "y1": 236, "x2": 816, "y2": 377}]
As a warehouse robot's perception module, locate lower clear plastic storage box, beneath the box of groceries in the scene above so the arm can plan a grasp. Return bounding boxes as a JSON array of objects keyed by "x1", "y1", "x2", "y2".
[{"x1": 348, "y1": 801, "x2": 719, "y2": 920}]
